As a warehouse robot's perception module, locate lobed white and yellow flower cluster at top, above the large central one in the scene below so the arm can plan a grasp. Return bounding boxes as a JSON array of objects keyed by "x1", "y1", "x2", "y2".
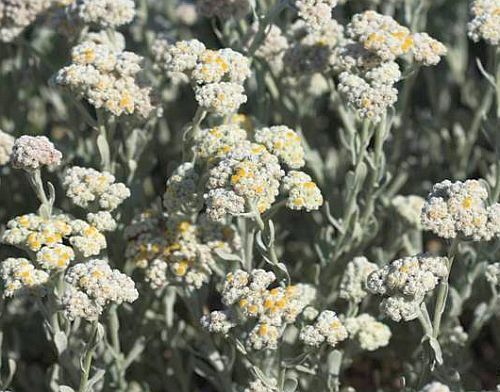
[{"x1": 153, "y1": 38, "x2": 251, "y2": 115}]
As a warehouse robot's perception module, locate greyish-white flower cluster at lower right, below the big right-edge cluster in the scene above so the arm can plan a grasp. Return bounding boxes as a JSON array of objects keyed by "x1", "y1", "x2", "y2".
[{"x1": 367, "y1": 254, "x2": 448, "y2": 321}]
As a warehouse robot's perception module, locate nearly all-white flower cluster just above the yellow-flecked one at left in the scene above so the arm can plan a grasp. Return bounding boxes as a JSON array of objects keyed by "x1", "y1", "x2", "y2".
[{"x1": 63, "y1": 166, "x2": 130, "y2": 213}]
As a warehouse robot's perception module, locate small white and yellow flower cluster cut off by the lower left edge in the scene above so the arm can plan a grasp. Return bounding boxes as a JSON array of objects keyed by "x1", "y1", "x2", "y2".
[{"x1": 0, "y1": 257, "x2": 49, "y2": 298}]
